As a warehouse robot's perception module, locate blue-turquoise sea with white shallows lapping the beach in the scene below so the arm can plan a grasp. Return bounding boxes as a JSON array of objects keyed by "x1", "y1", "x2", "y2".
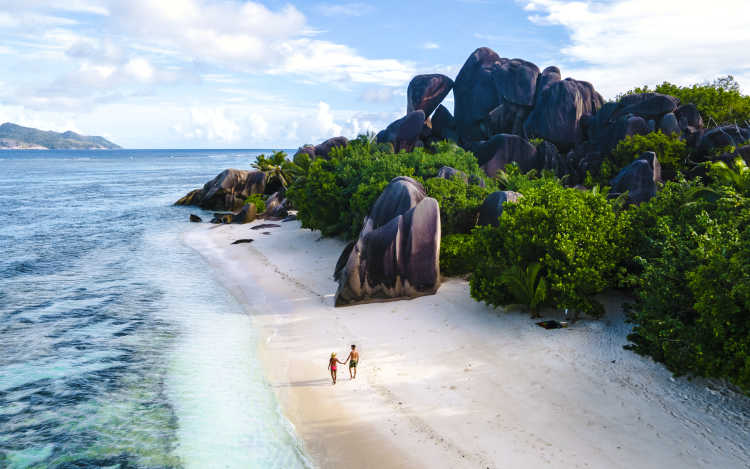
[{"x1": 0, "y1": 150, "x2": 309, "y2": 468}]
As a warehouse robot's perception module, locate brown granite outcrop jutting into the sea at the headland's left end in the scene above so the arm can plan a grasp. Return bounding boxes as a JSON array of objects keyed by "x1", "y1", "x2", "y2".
[{"x1": 175, "y1": 169, "x2": 266, "y2": 210}]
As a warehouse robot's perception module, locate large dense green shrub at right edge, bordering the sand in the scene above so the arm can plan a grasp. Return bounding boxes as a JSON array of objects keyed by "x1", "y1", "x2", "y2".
[{"x1": 628, "y1": 180, "x2": 750, "y2": 391}]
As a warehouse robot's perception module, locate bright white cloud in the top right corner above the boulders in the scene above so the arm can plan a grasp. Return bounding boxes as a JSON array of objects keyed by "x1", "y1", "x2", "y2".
[{"x1": 523, "y1": 0, "x2": 750, "y2": 97}]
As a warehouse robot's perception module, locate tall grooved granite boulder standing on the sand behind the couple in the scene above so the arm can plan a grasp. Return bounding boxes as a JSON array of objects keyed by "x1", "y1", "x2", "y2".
[{"x1": 334, "y1": 177, "x2": 440, "y2": 306}]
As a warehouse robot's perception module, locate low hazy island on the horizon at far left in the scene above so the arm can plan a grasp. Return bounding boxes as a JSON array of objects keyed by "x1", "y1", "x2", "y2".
[{"x1": 0, "y1": 122, "x2": 121, "y2": 150}]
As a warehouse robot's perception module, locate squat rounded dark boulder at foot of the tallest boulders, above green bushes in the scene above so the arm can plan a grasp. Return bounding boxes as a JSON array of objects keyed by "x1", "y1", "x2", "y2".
[{"x1": 477, "y1": 134, "x2": 541, "y2": 177}]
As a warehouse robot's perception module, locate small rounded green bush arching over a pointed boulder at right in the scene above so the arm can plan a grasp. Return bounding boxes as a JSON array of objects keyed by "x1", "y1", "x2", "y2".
[{"x1": 610, "y1": 131, "x2": 688, "y2": 174}]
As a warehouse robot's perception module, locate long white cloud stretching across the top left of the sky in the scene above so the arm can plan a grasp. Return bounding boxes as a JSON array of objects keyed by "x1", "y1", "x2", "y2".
[{"x1": 106, "y1": 0, "x2": 414, "y2": 85}]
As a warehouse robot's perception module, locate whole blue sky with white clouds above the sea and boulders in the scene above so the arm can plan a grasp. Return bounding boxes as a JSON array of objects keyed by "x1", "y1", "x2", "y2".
[{"x1": 0, "y1": 0, "x2": 750, "y2": 149}]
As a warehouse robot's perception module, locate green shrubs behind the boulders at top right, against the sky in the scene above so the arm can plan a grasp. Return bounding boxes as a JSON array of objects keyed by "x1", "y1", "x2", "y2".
[{"x1": 625, "y1": 75, "x2": 750, "y2": 127}]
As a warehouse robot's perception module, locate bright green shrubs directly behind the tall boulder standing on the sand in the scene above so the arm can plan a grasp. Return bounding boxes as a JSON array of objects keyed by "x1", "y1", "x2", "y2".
[{"x1": 287, "y1": 139, "x2": 483, "y2": 239}]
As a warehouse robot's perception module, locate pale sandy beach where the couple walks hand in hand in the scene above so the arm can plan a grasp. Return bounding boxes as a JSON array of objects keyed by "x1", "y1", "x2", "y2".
[{"x1": 184, "y1": 221, "x2": 750, "y2": 468}]
